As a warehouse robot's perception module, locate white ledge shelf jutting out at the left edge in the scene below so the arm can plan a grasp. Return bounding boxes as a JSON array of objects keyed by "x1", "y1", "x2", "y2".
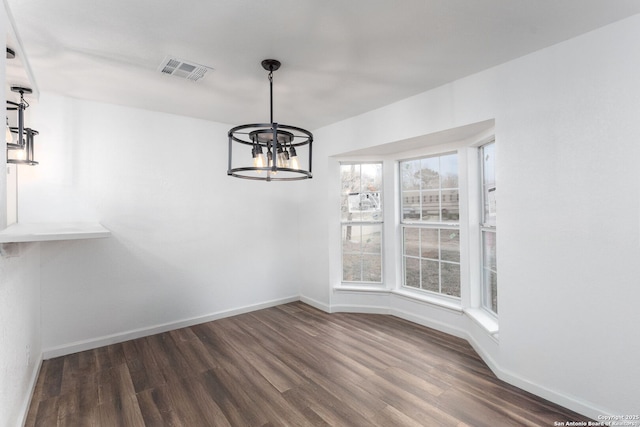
[{"x1": 0, "y1": 222, "x2": 111, "y2": 243}]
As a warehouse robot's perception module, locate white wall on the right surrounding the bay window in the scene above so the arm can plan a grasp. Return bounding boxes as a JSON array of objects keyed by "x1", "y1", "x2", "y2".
[{"x1": 301, "y1": 16, "x2": 640, "y2": 417}]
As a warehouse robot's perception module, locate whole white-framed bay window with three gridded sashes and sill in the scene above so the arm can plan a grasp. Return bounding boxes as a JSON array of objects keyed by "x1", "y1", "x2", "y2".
[{"x1": 336, "y1": 134, "x2": 498, "y2": 334}]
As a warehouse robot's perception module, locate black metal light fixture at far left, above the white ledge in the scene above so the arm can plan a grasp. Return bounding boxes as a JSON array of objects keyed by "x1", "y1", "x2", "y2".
[{"x1": 5, "y1": 86, "x2": 38, "y2": 166}]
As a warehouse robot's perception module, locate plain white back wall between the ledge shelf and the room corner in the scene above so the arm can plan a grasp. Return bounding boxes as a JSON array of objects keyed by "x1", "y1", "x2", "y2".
[{"x1": 19, "y1": 93, "x2": 302, "y2": 356}]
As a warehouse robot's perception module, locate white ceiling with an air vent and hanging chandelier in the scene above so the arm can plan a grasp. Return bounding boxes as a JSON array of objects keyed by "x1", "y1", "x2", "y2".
[{"x1": 5, "y1": 0, "x2": 640, "y2": 130}]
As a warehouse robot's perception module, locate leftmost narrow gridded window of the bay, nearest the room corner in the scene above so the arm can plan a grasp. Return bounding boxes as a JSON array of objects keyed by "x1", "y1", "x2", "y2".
[{"x1": 340, "y1": 163, "x2": 383, "y2": 283}]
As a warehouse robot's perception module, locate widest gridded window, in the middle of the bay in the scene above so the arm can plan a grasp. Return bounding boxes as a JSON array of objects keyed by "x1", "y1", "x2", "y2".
[{"x1": 400, "y1": 153, "x2": 460, "y2": 298}]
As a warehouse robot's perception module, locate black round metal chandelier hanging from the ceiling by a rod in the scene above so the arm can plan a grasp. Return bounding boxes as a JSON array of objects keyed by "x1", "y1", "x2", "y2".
[{"x1": 227, "y1": 59, "x2": 313, "y2": 181}]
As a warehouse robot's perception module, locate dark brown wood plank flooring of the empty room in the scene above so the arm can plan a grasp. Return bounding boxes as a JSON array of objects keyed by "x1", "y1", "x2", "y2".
[{"x1": 26, "y1": 302, "x2": 588, "y2": 427}]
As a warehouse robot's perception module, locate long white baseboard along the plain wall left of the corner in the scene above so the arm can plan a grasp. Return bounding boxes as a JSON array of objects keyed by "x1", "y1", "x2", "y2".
[{"x1": 42, "y1": 295, "x2": 300, "y2": 360}]
